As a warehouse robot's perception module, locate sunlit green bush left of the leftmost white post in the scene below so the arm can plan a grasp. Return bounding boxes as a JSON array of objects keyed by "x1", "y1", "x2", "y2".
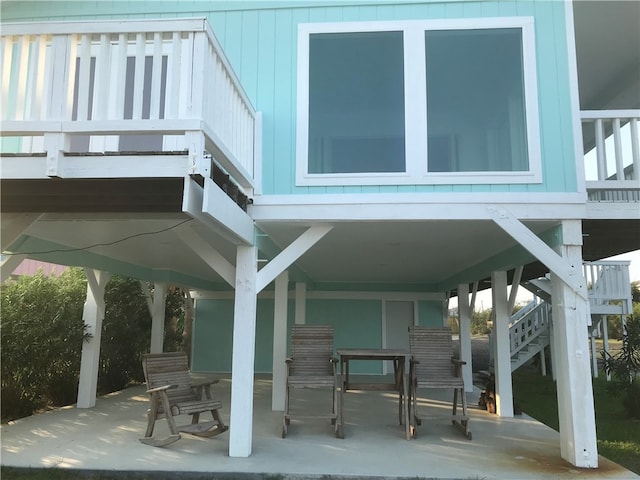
[{"x1": 0, "y1": 269, "x2": 87, "y2": 420}]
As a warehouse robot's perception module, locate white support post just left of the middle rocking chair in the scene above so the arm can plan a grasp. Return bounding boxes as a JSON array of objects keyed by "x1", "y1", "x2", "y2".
[{"x1": 271, "y1": 270, "x2": 289, "y2": 411}]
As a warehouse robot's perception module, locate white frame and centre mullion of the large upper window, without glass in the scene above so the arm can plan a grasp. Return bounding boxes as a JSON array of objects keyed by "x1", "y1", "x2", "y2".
[{"x1": 296, "y1": 17, "x2": 542, "y2": 186}]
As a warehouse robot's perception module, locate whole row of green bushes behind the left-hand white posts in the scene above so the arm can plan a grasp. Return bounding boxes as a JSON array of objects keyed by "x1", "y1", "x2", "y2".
[{"x1": 0, "y1": 268, "x2": 184, "y2": 421}]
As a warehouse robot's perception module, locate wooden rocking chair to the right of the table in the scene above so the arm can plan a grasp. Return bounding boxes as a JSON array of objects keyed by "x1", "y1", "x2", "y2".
[{"x1": 409, "y1": 326, "x2": 471, "y2": 440}]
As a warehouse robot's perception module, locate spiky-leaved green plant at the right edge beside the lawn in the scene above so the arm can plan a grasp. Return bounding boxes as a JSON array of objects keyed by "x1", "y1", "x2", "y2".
[{"x1": 602, "y1": 317, "x2": 640, "y2": 418}]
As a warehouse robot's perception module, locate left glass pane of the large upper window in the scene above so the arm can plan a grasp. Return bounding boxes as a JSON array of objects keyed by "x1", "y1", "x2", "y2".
[{"x1": 308, "y1": 32, "x2": 405, "y2": 173}]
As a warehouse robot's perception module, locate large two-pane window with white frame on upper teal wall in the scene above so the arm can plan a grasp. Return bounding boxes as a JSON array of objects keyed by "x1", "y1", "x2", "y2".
[{"x1": 297, "y1": 18, "x2": 540, "y2": 185}]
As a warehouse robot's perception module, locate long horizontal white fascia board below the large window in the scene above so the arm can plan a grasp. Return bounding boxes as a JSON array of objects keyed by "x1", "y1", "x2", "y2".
[{"x1": 249, "y1": 193, "x2": 586, "y2": 222}]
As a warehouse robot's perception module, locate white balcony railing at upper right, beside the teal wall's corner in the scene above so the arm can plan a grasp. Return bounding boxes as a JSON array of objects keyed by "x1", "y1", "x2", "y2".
[{"x1": 580, "y1": 110, "x2": 640, "y2": 202}]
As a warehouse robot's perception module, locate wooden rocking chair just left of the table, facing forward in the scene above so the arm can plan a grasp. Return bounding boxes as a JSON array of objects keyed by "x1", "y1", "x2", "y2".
[{"x1": 282, "y1": 325, "x2": 338, "y2": 438}]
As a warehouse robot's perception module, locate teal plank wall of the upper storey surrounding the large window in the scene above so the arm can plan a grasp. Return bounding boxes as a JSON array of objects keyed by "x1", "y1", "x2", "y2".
[{"x1": 2, "y1": 0, "x2": 577, "y2": 194}]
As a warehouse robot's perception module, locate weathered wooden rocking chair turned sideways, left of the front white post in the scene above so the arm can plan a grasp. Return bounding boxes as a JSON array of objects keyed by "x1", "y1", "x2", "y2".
[{"x1": 139, "y1": 352, "x2": 229, "y2": 447}]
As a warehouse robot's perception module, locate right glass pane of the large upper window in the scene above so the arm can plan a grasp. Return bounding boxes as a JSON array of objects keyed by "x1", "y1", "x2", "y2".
[{"x1": 425, "y1": 28, "x2": 529, "y2": 172}]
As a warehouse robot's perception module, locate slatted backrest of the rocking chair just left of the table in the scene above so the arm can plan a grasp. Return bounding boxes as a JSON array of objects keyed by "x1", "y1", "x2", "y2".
[{"x1": 289, "y1": 325, "x2": 333, "y2": 376}]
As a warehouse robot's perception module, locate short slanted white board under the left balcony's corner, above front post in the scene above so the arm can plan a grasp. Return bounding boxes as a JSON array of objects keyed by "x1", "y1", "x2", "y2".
[{"x1": 202, "y1": 178, "x2": 254, "y2": 245}]
